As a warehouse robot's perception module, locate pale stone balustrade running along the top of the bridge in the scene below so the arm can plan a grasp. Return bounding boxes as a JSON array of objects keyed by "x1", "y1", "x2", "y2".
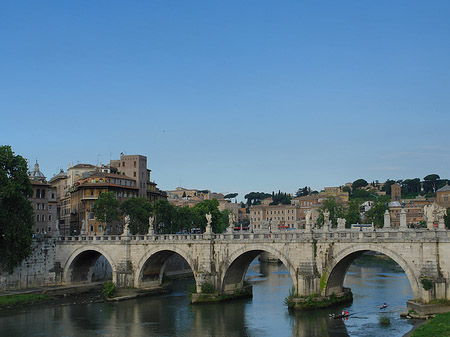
[{"x1": 59, "y1": 229, "x2": 450, "y2": 243}]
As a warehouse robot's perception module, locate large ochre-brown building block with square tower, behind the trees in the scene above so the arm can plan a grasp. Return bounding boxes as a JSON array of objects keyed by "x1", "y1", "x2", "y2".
[{"x1": 50, "y1": 154, "x2": 167, "y2": 235}]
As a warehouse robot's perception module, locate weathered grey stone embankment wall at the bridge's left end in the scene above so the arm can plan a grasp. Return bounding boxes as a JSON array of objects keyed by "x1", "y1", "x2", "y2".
[{"x1": 0, "y1": 239, "x2": 61, "y2": 290}]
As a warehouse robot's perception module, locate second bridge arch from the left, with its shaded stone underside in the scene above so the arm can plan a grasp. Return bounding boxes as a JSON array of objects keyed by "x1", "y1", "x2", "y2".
[{"x1": 134, "y1": 246, "x2": 195, "y2": 288}]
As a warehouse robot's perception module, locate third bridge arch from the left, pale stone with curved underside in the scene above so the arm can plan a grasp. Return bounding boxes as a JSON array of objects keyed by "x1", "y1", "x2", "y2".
[{"x1": 219, "y1": 245, "x2": 297, "y2": 291}]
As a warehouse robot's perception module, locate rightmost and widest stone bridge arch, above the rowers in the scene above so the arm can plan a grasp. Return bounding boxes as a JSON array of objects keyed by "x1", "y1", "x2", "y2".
[{"x1": 323, "y1": 244, "x2": 420, "y2": 298}]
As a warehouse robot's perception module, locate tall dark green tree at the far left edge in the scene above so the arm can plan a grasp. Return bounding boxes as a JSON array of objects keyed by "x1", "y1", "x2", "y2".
[{"x1": 0, "y1": 145, "x2": 34, "y2": 273}]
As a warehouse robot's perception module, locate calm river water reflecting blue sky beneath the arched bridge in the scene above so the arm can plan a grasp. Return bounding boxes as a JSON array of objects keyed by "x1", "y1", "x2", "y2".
[{"x1": 0, "y1": 260, "x2": 412, "y2": 337}]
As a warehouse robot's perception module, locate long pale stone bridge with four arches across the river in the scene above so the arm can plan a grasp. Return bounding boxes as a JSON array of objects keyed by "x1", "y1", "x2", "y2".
[{"x1": 56, "y1": 229, "x2": 450, "y2": 303}]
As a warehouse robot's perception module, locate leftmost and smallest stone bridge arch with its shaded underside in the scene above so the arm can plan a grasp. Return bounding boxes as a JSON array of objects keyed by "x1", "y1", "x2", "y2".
[{"x1": 63, "y1": 246, "x2": 116, "y2": 283}]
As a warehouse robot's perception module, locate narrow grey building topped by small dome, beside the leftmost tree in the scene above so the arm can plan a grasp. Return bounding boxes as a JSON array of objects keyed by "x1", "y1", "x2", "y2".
[{"x1": 29, "y1": 161, "x2": 59, "y2": 237}]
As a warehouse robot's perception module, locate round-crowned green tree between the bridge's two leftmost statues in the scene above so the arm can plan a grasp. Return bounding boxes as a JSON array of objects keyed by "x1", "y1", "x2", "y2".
[{"x1": 120, "y1": 197, "x2": 153, "y2": 234}]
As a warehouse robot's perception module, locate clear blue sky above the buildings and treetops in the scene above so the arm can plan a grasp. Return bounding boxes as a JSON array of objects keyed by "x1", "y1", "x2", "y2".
[{"x1": 0, "y1": 0, "x2": 450, "y2": 199}]
